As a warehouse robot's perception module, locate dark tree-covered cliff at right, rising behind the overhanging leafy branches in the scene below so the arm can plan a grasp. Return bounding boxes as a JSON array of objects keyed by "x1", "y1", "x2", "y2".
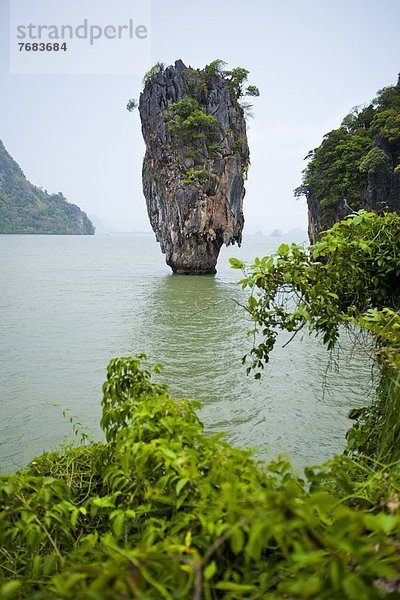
[{"x1": 295, "y1": 83, "x2": 400, "y2": 241}]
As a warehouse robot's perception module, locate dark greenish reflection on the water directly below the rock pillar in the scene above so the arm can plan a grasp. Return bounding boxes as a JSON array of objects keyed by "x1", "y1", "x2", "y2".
[{"x1": 138, "y1": 275, "x2": 244, "y2": 398}]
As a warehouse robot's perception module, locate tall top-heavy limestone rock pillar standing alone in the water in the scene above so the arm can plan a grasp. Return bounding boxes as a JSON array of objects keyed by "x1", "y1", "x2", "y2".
[{"x1": 139, "y1": 60, "x2": 249, "y2": 274}]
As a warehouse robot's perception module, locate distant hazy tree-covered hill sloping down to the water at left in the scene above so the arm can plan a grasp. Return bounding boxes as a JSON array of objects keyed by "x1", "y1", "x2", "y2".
[{"x1": 0, "y1": 141, "x2": 94, "y2": 235}]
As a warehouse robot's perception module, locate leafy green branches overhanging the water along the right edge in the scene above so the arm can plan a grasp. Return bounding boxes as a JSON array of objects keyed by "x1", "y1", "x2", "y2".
[{"x1": 231, "y1": 206, "x2": 400, "y2": 488}]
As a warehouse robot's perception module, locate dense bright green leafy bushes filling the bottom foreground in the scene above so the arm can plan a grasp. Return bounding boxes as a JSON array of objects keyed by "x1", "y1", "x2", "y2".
[{"x1": 0, "y1": 357, "x2": 400, "y2": 600}]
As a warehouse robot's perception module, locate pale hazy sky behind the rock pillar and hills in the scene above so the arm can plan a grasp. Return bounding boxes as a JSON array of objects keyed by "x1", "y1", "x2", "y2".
[{"x1": 0, "y1": 0, "x2": 400, "y2": 233}]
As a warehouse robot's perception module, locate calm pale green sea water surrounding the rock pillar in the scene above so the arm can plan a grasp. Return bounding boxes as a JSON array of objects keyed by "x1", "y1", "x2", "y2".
[{"x1": 0, "y1": 234, "x2": 371, "y2": 471}]
